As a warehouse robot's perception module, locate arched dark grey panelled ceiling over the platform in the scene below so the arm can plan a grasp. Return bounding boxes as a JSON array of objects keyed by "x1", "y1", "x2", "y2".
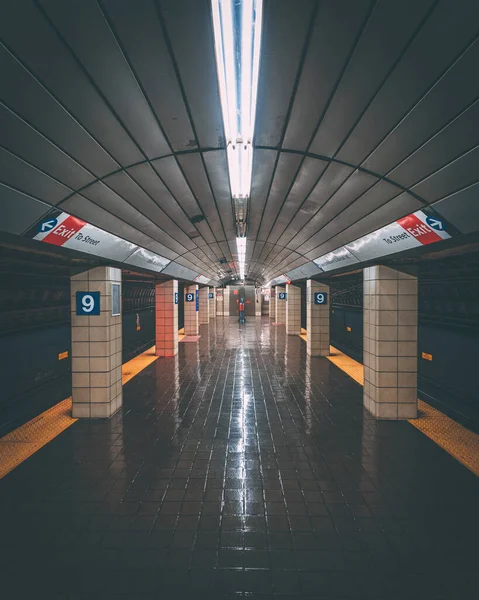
[{"x1": 0, "y1": 0, "x2": 479, "y2": 281}]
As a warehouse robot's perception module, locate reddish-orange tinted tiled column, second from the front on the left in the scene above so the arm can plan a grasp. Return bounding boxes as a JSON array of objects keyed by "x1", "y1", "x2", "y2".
[{"x1": 155, "y1": 279, "x2": 178, "y2": 356}]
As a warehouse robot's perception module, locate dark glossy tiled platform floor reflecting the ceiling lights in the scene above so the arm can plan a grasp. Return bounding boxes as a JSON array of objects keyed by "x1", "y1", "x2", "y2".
[{"x1": 0, "y1": 318, "x2": 479, "y2": 600}]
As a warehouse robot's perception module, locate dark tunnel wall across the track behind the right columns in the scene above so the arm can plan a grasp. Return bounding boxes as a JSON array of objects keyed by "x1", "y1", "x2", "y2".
[{"x1": 331, "y1": 253, "x2": 479, "y2": 430}]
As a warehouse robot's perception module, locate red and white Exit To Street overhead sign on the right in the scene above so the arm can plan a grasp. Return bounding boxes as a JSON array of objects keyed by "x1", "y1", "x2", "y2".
[{"x1": 313, "y1": 210, "x2": 451, "y2": 271}]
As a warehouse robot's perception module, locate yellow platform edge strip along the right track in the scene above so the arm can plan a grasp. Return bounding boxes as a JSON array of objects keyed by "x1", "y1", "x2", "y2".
[{"x1": 300, "y1": 335, "x2": 479, "y2": 476}]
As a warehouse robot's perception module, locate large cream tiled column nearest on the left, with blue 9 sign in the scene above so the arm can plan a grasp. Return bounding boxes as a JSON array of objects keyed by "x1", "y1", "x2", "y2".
[{"x1": 70, "y1": 267, "x2": 123, "y2": 419}]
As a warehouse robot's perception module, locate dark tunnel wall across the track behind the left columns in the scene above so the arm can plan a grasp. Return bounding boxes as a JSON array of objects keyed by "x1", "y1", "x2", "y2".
[{"x1": 0, "y1": 272, "x2": 172, "y2": 436}]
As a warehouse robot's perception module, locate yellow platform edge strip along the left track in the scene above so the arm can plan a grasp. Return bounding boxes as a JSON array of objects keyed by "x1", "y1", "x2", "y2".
[{"x1": 0, "y1": 346, "x2": 158, "y2": 479}]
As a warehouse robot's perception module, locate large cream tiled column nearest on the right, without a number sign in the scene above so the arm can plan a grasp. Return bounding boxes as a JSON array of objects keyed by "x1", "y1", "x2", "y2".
[{"x1": 363, "y1": 265, "x2": 417, "y2": 420}]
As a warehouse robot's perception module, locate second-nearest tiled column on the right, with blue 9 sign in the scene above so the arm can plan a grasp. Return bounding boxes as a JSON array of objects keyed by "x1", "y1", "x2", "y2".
[{"x1": 306, "y1": 279, "x2": 330, "y2": 356}]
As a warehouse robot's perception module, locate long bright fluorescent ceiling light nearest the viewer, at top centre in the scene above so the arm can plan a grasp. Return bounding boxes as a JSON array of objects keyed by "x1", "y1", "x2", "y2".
[{"x1": 211, "y1": 0, "x2": 263, "y2": 198}]
